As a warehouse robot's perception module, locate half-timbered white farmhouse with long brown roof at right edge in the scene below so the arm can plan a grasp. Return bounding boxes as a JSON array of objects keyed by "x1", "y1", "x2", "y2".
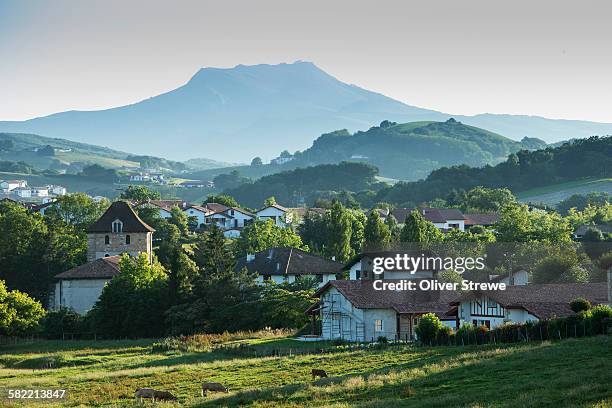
[{"x1": 451, "y1": 282, "x2": 608, "y2": 327}]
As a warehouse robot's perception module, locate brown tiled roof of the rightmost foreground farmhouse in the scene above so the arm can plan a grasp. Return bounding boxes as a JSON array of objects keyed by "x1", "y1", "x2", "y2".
[{"x1": 450, "y1": 282, "x2": 608, "y2": 319}]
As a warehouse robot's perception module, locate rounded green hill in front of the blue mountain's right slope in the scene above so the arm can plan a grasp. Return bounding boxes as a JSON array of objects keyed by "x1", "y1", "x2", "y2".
[{"x1": 290, "y1": 119, "x2": 526, "y2": 180}]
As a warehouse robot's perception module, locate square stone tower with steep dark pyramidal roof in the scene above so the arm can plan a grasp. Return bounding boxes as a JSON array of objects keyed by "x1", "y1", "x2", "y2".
[{"x1": 87, "y1": 201, "x2": 155, "y2": 262}]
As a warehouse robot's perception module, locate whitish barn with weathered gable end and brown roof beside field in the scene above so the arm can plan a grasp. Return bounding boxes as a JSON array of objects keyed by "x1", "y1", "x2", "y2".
[{"x1": 309, "y1": 280, "x2": 458, "y2": 342}]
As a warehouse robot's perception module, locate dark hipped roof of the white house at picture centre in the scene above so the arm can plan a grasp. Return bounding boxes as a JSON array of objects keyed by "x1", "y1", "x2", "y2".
[{"x1": 236, "y1": 248, "x2": 342, "y2": 275}]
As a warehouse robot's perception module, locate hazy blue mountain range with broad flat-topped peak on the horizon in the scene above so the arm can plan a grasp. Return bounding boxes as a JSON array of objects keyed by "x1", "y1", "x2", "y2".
[{"x1": 0, "y1": 62, "x2": 612, "y2": 162}]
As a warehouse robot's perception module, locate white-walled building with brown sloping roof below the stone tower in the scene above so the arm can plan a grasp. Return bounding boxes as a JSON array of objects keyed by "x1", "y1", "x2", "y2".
[{"x1": 50, "y1": 255, "x2": 121, "y2": 314}]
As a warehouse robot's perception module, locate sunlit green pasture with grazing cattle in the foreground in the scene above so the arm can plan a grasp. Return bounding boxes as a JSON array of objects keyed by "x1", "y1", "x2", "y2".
[{"x1": 0, "y1": 336, "x2": 612, "y2": 407}]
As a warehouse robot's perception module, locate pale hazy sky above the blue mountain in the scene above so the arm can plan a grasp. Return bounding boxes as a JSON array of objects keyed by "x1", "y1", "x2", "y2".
[{"x1": 0, "y1": 0, "x2": 612, "y2": 122}]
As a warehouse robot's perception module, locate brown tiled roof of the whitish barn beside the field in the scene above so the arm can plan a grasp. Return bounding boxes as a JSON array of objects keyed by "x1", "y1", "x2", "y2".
[{"x1": 315, "y1": 279, "x2": 459, "y2": 316}]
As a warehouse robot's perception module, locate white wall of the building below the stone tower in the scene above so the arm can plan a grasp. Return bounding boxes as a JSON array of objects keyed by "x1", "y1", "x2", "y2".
[{"x1": 54, "y1": 279, "x2": 109, "y2": 314}]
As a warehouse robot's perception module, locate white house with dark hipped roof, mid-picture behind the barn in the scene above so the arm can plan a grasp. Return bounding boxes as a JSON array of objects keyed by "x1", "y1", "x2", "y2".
[{"x1": 236, "y1": 248, "x2": 342, "y2": 286}]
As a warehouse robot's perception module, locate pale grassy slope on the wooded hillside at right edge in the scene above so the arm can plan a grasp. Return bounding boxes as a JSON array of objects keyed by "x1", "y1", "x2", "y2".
[{"x1": 516, "y1": 178, "x2": 612, "y2": 205}]
